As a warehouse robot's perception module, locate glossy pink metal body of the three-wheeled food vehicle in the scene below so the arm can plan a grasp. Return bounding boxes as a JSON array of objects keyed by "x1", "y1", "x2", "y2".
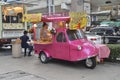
[{"x1": 34, "y1": 29, "x2": 98, "y2": 61}]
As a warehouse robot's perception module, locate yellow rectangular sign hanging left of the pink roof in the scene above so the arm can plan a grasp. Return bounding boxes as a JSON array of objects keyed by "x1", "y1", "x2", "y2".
[{"x1": 22, "y1": 13, "x2": 42, "y2": 22}]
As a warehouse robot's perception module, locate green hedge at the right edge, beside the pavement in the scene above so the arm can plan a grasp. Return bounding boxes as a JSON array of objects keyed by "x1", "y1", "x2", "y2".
[{"x1": 108, "y1": 44, "x2": 120, "y2": 62}]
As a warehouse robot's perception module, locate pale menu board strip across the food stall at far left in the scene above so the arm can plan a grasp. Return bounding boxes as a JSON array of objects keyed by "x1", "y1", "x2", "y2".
[{"x1": 3, "y1": 23, "x2": 24, "y2": 29}]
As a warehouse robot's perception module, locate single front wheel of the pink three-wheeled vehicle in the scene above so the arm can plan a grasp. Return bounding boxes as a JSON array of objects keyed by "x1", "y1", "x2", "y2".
[{"x1": 84, "y1": 57, "x2": 96, "y2": 69}]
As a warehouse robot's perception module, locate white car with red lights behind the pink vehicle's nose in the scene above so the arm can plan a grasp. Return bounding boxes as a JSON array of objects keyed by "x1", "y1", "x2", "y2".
[{"x1": 86, "y1": 32, "x2": 103, "y2": 44}]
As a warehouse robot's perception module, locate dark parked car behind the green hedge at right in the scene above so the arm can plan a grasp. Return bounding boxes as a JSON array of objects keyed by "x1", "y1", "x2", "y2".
[{"x1": 90, "y1": 27, "x2": 120, "y2": 43}]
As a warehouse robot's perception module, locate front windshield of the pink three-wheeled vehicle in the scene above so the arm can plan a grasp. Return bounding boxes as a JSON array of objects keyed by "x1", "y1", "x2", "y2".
[{"x1": 67, "y1": 30, "x2": 86, "y2": 41}]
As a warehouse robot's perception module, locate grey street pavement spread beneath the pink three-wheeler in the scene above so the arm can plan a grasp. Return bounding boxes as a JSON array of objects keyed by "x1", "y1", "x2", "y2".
[{"x1": 0, "y1": 47, "x2": 120, "y2": 80}]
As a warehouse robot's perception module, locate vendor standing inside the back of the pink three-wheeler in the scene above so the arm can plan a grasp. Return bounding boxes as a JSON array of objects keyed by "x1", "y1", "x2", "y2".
[{"x1": 40, "y1": 22, "x2": 52, "y2": 41}]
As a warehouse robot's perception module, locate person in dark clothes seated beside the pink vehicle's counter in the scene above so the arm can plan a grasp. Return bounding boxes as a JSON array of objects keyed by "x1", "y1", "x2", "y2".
[{"x1": 20, "y1": 31, "x2": 33, "y2": 56}]
